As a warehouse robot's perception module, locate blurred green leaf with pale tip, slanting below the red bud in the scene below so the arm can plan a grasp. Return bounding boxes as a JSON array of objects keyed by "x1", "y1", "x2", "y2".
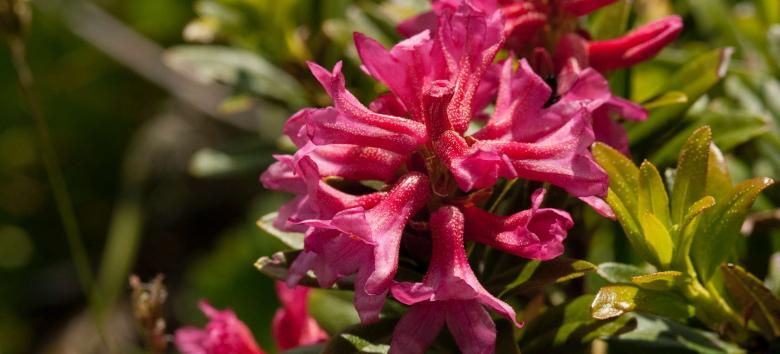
[{"x1": 628, "y1": 48, "x2": 734, "y2": 144}]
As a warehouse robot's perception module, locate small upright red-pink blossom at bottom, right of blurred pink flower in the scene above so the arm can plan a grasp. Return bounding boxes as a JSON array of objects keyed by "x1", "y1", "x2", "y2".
[{"x1": 271, "y1": 282, "x2": 328, "y2": 350}]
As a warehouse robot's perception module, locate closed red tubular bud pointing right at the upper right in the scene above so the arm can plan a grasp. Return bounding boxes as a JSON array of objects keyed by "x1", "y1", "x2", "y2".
[{"x1": 588, "y1": 16, "x2": 683, "y2": 71}]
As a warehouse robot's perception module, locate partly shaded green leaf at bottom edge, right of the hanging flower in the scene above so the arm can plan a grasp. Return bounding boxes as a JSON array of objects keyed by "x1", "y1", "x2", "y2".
[{"x1": 516, "y1": 295, "x2": 629, "y2": 354}]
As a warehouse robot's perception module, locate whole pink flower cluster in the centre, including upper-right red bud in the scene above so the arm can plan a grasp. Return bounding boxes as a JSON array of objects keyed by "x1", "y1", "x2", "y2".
[{"x1": 261, "y1": 0, "x2": 680, "y2": 353}]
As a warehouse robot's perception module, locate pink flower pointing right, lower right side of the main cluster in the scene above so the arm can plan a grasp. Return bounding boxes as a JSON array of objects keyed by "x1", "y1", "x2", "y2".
[{"x1": 463, "y1": 189, "x2": 574, "y2": 260}]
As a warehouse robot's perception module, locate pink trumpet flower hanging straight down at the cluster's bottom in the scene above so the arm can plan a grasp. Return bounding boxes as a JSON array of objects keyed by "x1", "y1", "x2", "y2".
[{"x1": 390, "y1": 206, "x2": 521, "y2": 354}]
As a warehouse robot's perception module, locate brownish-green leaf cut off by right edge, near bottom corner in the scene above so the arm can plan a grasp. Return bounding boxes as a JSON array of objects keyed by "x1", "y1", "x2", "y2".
[{"x1": 720, "y1": 264, "x2": 780, "y2": 339}]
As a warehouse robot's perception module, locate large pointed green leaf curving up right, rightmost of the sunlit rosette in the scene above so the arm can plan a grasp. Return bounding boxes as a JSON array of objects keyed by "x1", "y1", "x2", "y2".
[{"x1": 691, "y1": 177, "x2": 774, "y2": 283}]
